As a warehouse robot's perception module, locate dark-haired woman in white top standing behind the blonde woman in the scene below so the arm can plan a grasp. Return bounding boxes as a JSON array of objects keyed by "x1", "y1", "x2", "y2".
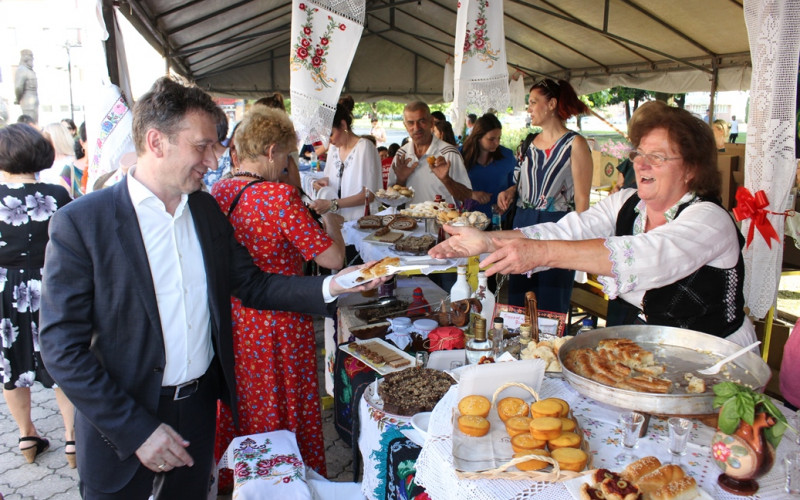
[{"x1": 310, "y1": 96, "x2": 383, "y2": 221}]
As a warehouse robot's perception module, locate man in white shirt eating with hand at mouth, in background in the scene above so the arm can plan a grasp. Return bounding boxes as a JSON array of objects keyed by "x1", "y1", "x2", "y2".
[{"x1": 388, "y1": 101, "x2": 472, "y2": 203}]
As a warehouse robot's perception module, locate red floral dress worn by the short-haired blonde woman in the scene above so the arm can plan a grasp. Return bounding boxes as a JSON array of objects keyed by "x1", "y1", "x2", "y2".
[{"x1": 212, "y1": 178, "x2": 333, "y2": 480}]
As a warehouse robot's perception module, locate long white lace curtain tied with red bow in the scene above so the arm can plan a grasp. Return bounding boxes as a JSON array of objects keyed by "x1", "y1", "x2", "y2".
[{"x1": 742, "y1": 0, "x2": 800, "y2": 318}]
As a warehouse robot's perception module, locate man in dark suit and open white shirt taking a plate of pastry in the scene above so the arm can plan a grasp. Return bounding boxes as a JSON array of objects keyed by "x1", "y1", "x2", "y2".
[{"x1": 40, "y1": 78, "x2": 381, "y2": 500}]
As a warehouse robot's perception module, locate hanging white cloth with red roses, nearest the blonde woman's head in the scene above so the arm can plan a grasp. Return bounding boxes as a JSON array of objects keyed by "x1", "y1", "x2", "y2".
[{"x1": 289, "y1": 0, "x2": 365, "y2": 143}]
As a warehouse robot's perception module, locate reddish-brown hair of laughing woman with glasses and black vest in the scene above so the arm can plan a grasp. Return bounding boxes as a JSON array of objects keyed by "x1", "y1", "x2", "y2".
[{"x1": 629, "y1": 105, "x2": 722, "y2": 199}]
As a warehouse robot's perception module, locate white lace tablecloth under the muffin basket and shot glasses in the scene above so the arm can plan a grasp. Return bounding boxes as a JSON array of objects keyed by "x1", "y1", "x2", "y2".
[{"x1": 416, "y1": 378, "x2": 797, "y2": 500}]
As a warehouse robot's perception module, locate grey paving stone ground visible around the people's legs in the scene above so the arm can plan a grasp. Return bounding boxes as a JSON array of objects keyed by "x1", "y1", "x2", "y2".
[{"x1": 0, "y1": 321, "x2": 353, "y2": 500}]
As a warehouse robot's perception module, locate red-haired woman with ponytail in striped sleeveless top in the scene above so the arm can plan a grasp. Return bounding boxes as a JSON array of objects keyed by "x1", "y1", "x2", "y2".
[{"x1": 497, "y1": 78, "x2": 592, "y2": 313}]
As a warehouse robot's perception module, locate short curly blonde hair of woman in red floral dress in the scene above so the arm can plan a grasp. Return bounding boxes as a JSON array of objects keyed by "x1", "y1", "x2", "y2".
[{"x1": 233, "y1": 104, "x2": 297, "y2": 160}]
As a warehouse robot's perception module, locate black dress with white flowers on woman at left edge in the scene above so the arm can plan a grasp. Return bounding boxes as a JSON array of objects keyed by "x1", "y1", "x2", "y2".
[{"x1": 0, "y1": 183, "x2": 70, "y2": 390}]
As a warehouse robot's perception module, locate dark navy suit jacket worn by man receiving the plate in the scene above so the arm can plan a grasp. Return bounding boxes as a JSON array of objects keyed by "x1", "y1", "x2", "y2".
[{"x1": 40, "y1": 181, "x2": 335, "y2": 492}]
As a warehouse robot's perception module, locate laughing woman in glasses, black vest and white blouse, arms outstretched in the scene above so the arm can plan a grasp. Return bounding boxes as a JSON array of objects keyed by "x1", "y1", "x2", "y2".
[{"x1": 429, "y1": 104, "x2": 755, "y2": 345}]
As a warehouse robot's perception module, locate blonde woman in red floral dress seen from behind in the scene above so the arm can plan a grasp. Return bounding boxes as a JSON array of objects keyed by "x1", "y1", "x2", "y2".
[{"x1": 212, "y1": 106, "x2": 344, "y2": 489}]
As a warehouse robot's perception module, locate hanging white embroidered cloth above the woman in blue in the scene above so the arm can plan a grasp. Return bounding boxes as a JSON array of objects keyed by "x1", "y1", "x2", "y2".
[{"x1": 453, "y1": 0, "x2": 508, "y2": 130}]
